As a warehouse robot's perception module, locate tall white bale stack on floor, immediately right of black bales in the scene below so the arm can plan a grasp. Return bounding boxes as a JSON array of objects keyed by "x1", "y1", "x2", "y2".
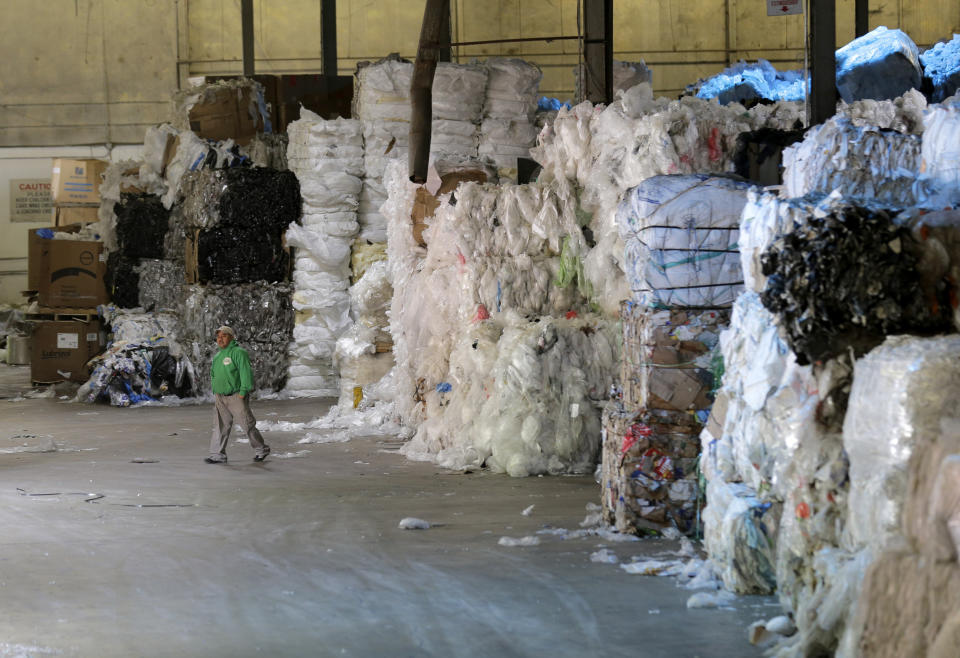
[{"x1": 286, "y1": 110, "x2": 363, "y2": 397}]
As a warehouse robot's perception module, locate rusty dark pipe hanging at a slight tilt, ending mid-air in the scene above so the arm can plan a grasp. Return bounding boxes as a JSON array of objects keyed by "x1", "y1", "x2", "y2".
[{"x1": 408, "y1": 0, "x2": 450, "y2": 184}]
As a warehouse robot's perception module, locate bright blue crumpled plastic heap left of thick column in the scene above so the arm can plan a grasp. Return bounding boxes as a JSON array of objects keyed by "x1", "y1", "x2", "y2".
[{"x1": 687, "y1": 59, "x2": 806, "y2": 105}]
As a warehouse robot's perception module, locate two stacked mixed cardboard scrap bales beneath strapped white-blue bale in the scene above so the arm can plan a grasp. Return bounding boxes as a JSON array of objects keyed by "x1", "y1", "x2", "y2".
[{"x1": 601, "y1": 301, "x2": 730, "y2": 533}]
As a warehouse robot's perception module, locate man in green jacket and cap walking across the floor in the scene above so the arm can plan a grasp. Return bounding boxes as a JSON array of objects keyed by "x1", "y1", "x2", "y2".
[{"x1": 203, "y1": 327, "x2": 270, "y2": 464}]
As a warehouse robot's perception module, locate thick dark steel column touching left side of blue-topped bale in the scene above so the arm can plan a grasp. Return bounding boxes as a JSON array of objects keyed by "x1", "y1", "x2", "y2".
[{"x1": 807, "y1": 0, "x2": 837, "y2": 126}]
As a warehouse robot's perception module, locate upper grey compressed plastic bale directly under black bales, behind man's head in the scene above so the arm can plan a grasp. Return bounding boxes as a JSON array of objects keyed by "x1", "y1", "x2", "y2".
[{"x1": 178, "y1": 281, "x2": 294, "y2": 346}]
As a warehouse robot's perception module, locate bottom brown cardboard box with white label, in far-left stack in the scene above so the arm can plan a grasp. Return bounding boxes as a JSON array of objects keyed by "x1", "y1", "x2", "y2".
[{"x1": 30, "y1": 320, "x2": 106, "y2": 383}]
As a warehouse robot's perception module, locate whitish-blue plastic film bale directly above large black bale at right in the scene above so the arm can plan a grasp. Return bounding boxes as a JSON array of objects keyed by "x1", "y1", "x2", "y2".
[{"x1": 781, "y1": 117, "x2": 929, "y2": 207}]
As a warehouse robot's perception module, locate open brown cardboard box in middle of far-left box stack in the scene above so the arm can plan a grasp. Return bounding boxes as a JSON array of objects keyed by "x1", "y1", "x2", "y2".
[{"x1": 27, "y1": 224, "x2": 109, "y2": 309}]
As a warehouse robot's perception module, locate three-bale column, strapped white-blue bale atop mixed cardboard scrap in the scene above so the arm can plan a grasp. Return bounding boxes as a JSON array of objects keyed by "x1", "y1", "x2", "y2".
[{"x1": 601, "y1": 175, "x2": 747, "y2": 534}]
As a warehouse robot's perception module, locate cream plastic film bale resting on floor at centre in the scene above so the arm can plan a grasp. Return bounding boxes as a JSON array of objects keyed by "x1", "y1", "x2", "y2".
[{"x1": 401, "y1": 313, "x2": 619, "y2": 477}]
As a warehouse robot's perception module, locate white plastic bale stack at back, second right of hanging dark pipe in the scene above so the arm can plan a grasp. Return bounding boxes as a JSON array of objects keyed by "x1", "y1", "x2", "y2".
[{"x1": 478, "y1": 58, "x2": 543, "y2": 180}]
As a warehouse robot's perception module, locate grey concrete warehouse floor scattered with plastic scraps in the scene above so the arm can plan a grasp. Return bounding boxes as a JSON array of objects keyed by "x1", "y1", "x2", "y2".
[{"x1": 0, "y1": 366, "x2": 779, "y2": 658}]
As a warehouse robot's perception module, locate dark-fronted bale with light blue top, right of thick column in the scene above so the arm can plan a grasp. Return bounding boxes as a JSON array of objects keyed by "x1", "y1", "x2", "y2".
[{"x1": 837, "y1": 25, "x2": 921, "y2": 103}]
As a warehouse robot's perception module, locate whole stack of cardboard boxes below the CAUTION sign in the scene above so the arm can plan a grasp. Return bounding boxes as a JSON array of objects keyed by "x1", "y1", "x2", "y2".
[{"x1": 26, "y1": 158, "x2": 107, "y2": 384}]
